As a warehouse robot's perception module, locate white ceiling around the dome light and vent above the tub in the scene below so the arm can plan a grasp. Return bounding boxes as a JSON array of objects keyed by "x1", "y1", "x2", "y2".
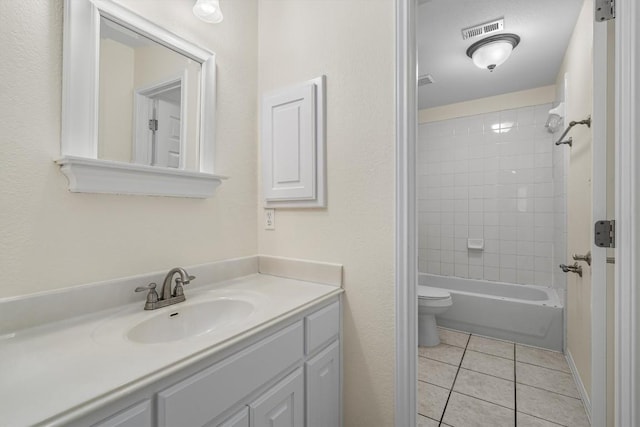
[{"x1": 418, "y1": 0, "x2": 583, "y2": 109}]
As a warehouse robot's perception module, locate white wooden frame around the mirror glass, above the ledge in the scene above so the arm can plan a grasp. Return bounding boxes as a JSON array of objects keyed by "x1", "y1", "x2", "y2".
[{"x1": 58, "y1": 0, "x2": 216, "y2": 197}]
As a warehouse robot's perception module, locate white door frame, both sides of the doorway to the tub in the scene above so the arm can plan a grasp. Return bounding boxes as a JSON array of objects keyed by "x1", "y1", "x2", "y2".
[{"x1": 395, "y1": 0, "x2": 640, "y2": 427}]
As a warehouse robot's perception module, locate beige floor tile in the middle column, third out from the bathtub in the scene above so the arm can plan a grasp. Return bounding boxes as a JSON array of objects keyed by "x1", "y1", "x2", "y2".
[{"x1": 453, "y1": 369, "x2": 515, "y2": 409}]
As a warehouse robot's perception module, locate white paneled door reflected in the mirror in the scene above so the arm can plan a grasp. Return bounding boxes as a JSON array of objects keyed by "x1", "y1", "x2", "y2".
[{"x1": 152, "y1": 99, "x2": 180, "y2": 168}]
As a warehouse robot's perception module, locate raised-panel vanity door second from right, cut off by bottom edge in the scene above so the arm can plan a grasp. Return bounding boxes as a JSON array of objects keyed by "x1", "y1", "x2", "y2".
[{"x1": 249, "y1": 368, "x2": 304, "y2": 427}]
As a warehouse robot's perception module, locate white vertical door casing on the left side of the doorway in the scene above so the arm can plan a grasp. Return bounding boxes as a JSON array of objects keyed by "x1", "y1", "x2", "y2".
[{"x1": 395, "y1": 0, "x2": 418, "y2": 427}]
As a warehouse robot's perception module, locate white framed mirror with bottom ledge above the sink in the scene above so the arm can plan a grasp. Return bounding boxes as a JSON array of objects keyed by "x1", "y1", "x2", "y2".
[{"x1": 56, "y1": 0, "x2": 224, "y2": 198}]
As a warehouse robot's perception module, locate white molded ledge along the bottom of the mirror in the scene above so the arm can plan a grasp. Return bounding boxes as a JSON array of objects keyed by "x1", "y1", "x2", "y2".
[{"x1": 56, "y1": 156, "x2": 226, "y2": 198}]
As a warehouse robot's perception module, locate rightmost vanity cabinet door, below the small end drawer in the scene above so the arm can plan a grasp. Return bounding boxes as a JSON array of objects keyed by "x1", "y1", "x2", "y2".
[{"x1": 306, "y1": 341, "x2": 340, "y2": 427}]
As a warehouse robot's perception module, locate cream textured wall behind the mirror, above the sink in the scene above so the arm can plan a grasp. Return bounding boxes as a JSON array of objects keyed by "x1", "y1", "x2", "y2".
[{"x1": 0, "y1": 0, "x2": 258, "y2": 297}]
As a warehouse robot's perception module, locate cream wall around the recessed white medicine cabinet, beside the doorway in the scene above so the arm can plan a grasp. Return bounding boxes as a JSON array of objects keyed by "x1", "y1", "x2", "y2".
[{"x1": 258, "y1": 0, "x2": 395, "y2": 426}]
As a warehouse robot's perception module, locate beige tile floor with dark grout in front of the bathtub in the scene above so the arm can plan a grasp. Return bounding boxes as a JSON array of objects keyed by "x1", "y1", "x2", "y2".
[{"x1": 418, "y1": 328, "x2": 589, "y2": 427}]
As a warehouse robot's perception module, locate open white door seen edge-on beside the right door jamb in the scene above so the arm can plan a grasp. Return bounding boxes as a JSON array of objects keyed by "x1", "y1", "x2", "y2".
[{"x1": 584, "y1": 15, "x2": 615, "y2": 427}]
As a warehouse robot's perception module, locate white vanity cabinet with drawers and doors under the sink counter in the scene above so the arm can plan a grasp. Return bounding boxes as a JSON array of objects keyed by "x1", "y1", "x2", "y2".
[{"x1": 84, "y1": 298, "x2": 341, "y2": 427}]
